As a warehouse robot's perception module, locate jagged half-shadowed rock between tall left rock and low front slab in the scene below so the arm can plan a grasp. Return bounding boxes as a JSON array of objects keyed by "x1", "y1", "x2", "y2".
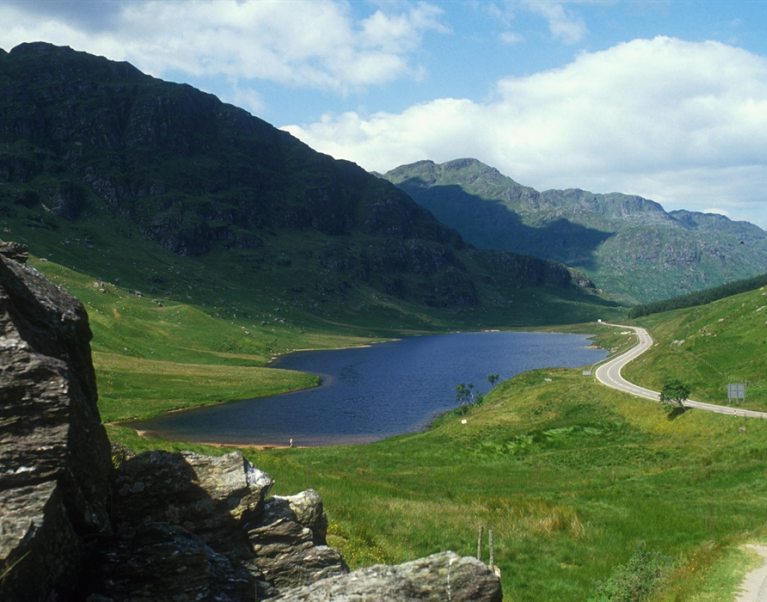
[{"x1": 85, "y1": 451, "x2": 348, "y2": 601}]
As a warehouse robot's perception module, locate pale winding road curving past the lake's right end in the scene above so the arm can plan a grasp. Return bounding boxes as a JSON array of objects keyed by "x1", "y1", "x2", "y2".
[{"x1": 595, "y1": 322, "x2": 767, "y2": 419}]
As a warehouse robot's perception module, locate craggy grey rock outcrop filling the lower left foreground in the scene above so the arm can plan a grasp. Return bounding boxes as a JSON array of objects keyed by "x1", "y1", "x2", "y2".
[{"x1": 0, "y1": 246, "x2": 502, "y2": 602}]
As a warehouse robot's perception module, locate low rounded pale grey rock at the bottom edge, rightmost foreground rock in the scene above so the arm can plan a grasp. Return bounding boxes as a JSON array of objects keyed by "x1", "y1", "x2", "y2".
[{"x1": 275, "y1": 552, "x2": 503, "y2": 602}]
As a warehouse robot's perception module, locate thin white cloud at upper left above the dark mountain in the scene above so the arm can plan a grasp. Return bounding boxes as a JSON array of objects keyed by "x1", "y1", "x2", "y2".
[{"x1": 0, "y1": 0, "x2": 447, "y2": 94}]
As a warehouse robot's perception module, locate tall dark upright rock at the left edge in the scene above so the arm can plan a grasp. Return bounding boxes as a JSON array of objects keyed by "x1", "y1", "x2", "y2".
[{"x1": 0, "y1": 245, "x2": 111, "y2": 601}]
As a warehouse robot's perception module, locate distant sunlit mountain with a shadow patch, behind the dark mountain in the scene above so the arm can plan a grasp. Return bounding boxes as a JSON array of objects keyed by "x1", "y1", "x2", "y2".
[{"x1": 384, "y1": 159, "x2": 767, "y2": 302}]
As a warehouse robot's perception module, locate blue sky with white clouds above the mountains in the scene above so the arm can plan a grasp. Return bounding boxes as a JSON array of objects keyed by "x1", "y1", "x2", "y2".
[{"x1": 0, "y1": 0, "x2": 767, "y2": 229}]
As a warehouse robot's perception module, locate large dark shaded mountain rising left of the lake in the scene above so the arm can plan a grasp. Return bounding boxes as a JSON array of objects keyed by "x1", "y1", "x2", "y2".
[{"x1": 0, "y1": 43, "x2": 616, "y2": 328}]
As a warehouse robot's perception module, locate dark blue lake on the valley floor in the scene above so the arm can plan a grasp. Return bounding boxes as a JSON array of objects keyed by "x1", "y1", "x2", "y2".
[{"x1": 136, "y1": 332, "x2": 606, "y2": 445}]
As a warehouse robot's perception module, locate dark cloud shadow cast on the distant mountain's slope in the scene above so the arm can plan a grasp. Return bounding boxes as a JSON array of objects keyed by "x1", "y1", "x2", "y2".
[{"x1": 399, "y1": 178, "x2": 612, "y2": 269}]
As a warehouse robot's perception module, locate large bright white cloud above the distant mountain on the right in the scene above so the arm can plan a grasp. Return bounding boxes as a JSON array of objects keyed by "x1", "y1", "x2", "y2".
[{"x1": 286, "y1": 37, "x2": 767, "y2": 225}]
